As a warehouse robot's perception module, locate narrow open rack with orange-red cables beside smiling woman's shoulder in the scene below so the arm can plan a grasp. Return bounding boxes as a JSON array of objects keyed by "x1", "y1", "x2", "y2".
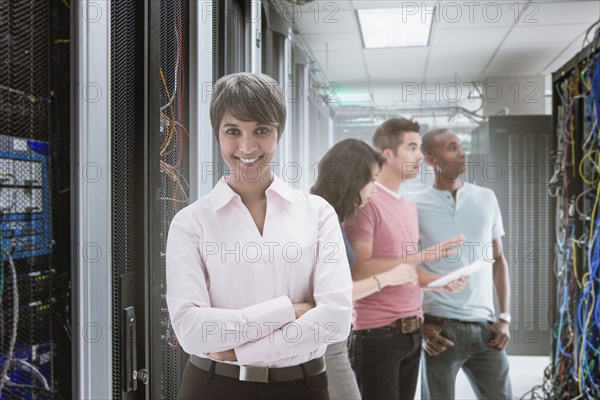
[{"x1": 158, "y1": 1, "x2": 191, "y2": 399}]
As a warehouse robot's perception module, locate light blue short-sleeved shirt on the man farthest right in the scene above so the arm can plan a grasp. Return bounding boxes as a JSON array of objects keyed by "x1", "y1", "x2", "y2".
[{"x1": 409, "y1": 182, "x2": 504, "y2": 321}]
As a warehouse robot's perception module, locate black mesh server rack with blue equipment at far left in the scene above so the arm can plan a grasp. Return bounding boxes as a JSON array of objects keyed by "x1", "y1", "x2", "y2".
[{"x1": 0, "y1": 0, "x2": 72, "y2": 399}]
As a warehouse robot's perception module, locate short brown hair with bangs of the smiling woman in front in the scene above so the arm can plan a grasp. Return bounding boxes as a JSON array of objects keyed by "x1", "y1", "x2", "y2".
[{"x1": 210, "y1": 72, "x2": 286, "y2": 141}]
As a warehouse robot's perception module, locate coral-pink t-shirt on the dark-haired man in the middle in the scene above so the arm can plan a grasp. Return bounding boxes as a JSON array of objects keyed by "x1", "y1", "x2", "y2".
[{"x1": 344, "y1": 187, "x2": 423, "y2": 329}]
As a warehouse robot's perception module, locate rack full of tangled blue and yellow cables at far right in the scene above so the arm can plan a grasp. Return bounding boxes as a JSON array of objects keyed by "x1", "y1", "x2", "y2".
[{"x1": 545, "y1": 38, "x2": 600, "y2": 398}]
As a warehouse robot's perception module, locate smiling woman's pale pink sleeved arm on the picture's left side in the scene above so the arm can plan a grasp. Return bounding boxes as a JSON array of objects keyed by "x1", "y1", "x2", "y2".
[{"x1": 166, "y1": 211, "x2": 296, "y2": 354}]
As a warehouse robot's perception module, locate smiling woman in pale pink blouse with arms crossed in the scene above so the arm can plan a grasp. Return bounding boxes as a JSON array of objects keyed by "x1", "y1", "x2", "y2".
[{"x1": 166, "y1": 73, "x2": 352, "y2": 399}]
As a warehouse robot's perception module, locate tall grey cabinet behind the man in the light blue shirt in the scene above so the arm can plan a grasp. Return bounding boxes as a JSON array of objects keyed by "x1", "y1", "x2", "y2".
[{"x1": 468, "y1": 116, "x2": 554, "y2": 355}]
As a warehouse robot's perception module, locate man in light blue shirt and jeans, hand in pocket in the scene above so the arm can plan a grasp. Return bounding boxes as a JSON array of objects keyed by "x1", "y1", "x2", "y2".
[{"x1": 413, "y1": 129, "x2": 512, "y2": 399}]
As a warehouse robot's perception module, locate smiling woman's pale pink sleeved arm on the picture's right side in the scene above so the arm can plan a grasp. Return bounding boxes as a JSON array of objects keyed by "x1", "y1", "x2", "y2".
[{"x1": 234, "y1": 200, "x2": 352, "y2": 365}]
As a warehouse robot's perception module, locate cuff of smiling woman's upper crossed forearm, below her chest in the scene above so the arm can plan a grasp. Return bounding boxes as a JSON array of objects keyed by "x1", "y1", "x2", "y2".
[{"x1": 242, "y1": 296, "x2": 296, "y2": 338}]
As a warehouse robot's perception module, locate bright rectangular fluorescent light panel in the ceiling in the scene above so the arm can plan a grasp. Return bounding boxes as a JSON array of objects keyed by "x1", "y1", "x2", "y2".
[{"x1": 356, "y1": 3, "x2": 435, "y2": 49}]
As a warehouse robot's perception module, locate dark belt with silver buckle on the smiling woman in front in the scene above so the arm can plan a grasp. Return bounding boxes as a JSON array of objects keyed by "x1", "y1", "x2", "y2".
[{"x1": 190, "y1": 354, "x2": 325, "y2": 383}]
